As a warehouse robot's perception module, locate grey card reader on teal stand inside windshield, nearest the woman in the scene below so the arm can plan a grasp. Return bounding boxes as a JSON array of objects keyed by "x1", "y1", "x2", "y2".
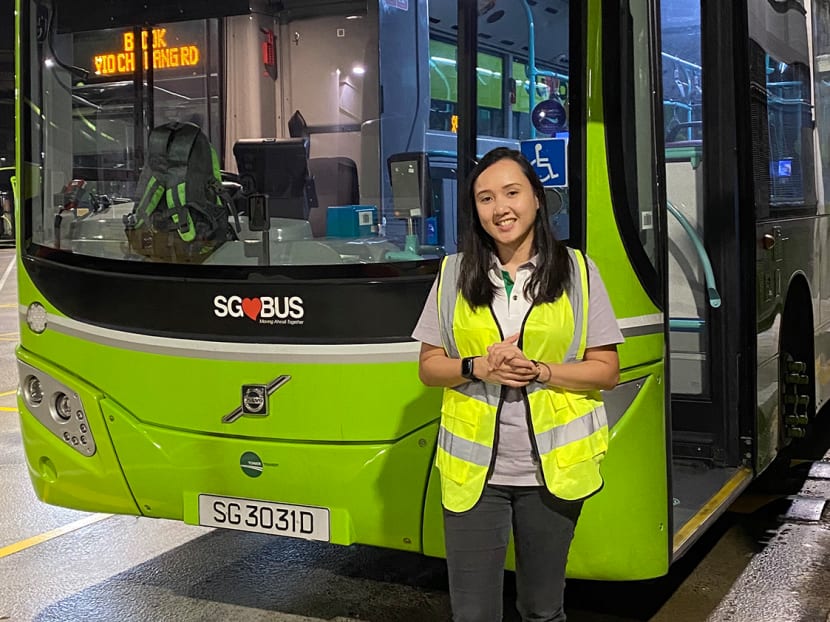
[{"x1": 388, "y1": 151, "x2": 437, "y2": 260}]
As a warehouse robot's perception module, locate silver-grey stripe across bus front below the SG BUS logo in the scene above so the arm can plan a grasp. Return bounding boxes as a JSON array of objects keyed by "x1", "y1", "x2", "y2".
[{"x1": 32, "y1": 314, "x2": 420, "y2": 364}]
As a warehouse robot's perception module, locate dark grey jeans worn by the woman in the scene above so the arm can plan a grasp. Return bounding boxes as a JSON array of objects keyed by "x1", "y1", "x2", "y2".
[{"x1": 444, "y1": 486, "x2": 582, "y2": 622}]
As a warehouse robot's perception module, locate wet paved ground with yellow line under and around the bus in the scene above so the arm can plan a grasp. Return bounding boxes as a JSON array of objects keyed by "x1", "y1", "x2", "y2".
[{"x1": 0, "y1": 249, "x2": 830, "y2": 622}]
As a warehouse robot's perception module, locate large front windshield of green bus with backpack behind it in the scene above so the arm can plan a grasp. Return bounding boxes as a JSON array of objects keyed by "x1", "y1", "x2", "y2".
[{"x1": 22, "y1": 0, "x2": 568, "y2": 266}]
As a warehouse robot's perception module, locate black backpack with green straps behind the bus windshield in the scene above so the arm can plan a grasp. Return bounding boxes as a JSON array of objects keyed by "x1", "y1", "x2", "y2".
[{"x1": 124, "y1": 122, "x2": 239, "y2": 263}]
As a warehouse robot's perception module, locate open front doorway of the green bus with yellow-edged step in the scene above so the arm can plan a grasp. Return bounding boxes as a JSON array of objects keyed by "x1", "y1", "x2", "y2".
[{"x1": 660, "y1": 0, "x2": 754, "y2": 553}]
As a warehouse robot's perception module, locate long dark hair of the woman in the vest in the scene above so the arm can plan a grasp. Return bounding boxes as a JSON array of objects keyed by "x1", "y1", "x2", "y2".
[{"x1": 458, "y1": 147, "x2": 571, "y2": 307}]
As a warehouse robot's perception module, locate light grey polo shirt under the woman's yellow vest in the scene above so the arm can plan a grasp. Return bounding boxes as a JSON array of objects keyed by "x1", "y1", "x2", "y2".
[{"x1": 412, "y1": 257, "x2": 623, "y2": 486}]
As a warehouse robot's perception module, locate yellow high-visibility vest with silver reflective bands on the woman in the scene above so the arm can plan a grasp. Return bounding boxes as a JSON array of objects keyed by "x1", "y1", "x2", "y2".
[{"x1": 435, "y1": 249, "x2": 608, "y2": 512}]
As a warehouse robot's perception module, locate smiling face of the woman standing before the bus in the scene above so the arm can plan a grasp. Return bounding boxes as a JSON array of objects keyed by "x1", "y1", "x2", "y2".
[{"x1": 473, "y1": 159, "x2": 539, "y2": 264}]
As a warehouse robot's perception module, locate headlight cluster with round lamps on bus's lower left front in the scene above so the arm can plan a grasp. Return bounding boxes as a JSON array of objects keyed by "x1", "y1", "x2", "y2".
[{"x1": 17, "y1": 361, "x2": 96, "y2": 456}]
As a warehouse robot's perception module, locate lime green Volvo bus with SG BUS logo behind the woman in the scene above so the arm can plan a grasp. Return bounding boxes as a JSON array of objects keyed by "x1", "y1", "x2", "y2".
[{"x1": 15, "y1": 0, "x2": 830, "y2": 580}]
